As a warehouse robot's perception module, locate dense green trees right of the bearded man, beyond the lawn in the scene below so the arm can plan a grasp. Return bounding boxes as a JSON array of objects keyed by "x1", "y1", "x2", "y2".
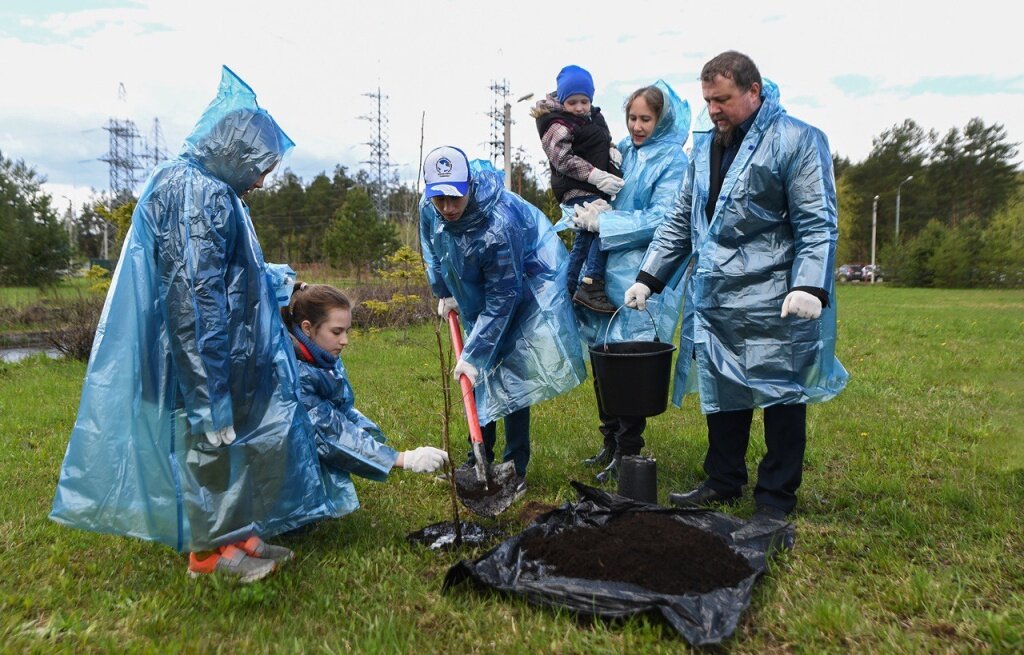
[{"x1": 834, "y1": 118, "x2": 1024, "y2": 288}]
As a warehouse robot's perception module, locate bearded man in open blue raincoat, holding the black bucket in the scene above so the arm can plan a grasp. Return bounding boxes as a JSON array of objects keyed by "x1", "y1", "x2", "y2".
[{"x1": 626, "y1": 51, "x2": 847, "y2": 520}]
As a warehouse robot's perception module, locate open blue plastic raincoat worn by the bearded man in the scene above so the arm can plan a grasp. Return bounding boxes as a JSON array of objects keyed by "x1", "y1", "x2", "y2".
[{"x1": 641, "y1": 80, "x2": 847, "y2": 413}]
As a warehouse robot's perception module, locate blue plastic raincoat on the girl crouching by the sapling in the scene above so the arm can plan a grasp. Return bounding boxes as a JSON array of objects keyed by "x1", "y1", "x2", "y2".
[{"x1": 299, "y1": 350, "x2": 398, "y2": 516}]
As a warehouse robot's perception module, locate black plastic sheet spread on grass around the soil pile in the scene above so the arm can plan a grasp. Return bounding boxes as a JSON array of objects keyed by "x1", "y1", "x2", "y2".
[{"x1": 443, "y1": 482, "x2": 796, "y2": 646}]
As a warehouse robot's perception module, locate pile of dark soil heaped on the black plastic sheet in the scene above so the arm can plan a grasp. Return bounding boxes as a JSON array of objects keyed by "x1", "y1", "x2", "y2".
[{"x1": 519, "y1": 512, "x2": 754, "y2": 595}]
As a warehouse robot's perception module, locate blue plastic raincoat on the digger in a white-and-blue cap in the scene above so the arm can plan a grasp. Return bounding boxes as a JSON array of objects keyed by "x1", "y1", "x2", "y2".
[{"x1": 420, "y1": 161, "x2": 587, "y2": 425}]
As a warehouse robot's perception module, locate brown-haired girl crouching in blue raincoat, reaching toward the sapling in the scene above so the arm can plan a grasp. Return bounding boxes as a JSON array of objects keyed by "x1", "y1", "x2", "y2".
[{"x1": 283, "y1": 282, "x2": 449, "y2": 515}]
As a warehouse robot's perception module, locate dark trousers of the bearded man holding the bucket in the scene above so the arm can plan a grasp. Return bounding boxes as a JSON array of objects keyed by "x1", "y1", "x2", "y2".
[{"x1": 705, "y1": 404, "x2": 807, "y2": 512}]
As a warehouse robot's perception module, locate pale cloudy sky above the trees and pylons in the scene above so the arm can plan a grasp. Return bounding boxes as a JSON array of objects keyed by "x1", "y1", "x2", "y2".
[{"x1": 0, "y1": 0, "x2": 1024, "y2": 208}]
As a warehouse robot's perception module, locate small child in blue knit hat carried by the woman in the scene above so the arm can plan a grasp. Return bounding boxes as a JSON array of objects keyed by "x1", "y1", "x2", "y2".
[{"x1": 530, "y1": 66, "x2": 623, "y2": 314}]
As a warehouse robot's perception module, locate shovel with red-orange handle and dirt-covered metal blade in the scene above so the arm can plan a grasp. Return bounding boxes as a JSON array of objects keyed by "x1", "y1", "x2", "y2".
[{"x1": 447, "y1": 311, "x2": 520, "y2": 517}]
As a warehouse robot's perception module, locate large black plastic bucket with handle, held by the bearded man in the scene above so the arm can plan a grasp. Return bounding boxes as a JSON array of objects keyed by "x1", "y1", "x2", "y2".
[{"x1": 590, "y1": 307, "x2": 676, "y2": 417}]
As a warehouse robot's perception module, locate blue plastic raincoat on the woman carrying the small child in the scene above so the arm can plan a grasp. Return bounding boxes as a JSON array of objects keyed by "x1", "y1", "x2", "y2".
[{"x1": 559, "y1": 80, "x2": 690, "y2": 346}]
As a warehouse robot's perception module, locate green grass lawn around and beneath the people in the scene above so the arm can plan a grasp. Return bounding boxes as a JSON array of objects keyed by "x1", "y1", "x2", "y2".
[{"x1": 0, "y1": 286, "x2": 1024, "y2": 653}]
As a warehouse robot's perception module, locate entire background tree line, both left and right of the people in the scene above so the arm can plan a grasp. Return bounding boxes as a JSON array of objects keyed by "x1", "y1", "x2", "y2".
[{"x1": 0, "y1": 119, "x2": 1024, "y2": 287}]
